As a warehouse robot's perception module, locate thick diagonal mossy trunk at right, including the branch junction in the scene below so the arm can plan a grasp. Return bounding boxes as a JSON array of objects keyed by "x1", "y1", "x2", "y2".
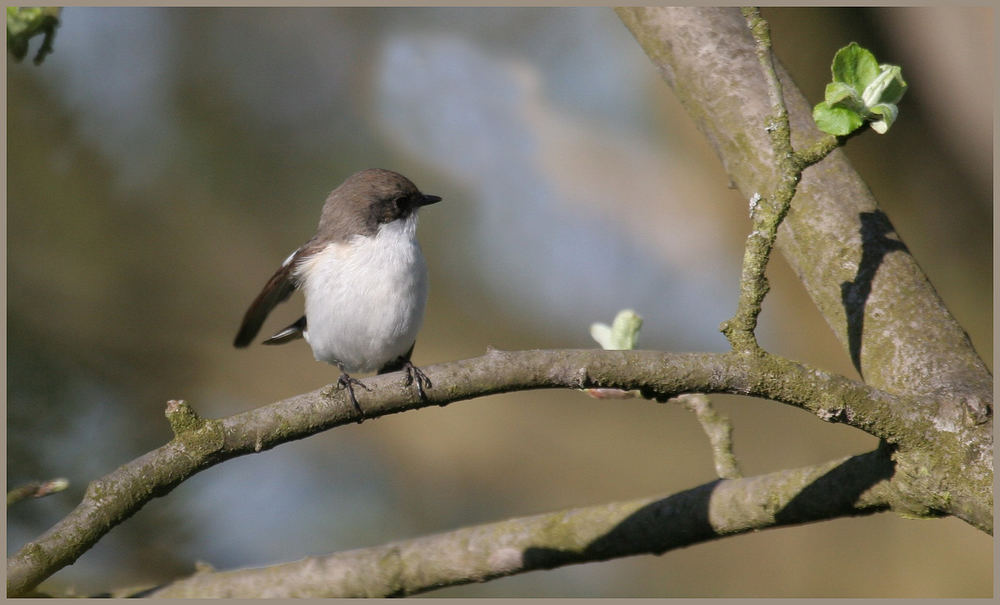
[{"x1": 616, "y1": 7, "x2": 993, "y2": 531}]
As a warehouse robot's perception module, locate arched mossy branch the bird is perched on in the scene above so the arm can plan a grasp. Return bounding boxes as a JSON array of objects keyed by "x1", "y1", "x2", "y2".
[{"x1": 7, "y1": 349, "x2": 934, "y2": 595}]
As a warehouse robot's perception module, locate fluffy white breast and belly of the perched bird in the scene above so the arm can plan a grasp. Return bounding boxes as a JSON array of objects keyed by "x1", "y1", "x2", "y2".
[{"x1": 296, "y1": 213, "x2": 427, "y2": 372}]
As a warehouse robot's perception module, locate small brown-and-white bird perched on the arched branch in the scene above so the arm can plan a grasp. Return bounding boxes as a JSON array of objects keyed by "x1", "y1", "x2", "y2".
[{"x1": 233, "y1": 168, "x2": 441, "y2": 415}]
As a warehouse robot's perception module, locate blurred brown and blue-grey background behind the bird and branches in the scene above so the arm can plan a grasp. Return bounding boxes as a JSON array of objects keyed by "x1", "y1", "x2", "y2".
[{"x1": 6, "y1": 6, "x2": 996, "y2": 597}]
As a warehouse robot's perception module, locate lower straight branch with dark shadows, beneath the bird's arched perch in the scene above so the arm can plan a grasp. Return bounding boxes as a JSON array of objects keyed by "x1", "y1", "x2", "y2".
[{"x1": 144, "y1": 450, "x2": 893, "y2": 598}]
